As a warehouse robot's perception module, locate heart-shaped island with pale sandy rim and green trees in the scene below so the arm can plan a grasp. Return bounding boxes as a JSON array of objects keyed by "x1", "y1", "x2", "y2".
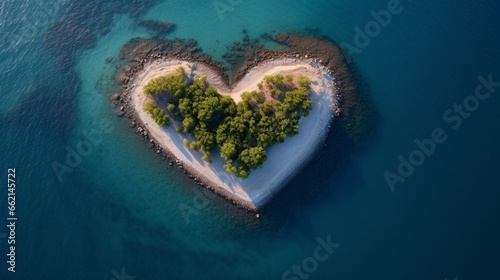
[{"x1": 129, "y1": 58, "x2": 338, "y2": 210}]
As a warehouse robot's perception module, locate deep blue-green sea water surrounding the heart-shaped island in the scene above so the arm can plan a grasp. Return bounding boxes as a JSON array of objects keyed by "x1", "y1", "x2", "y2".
[{"x1": 0, "y1": 0, "x2": 500, "y2": 280}]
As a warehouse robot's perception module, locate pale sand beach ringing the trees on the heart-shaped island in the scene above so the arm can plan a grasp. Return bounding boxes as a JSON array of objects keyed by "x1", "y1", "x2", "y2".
[{"x1": 131, "y1": 59, "x2": 337, "y2": 208}]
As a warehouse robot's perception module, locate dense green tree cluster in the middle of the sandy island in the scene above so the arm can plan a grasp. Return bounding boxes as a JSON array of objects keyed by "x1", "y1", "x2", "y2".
[{"x1": 144, "y1": 72, "x2": 312, "y2": 178}]
